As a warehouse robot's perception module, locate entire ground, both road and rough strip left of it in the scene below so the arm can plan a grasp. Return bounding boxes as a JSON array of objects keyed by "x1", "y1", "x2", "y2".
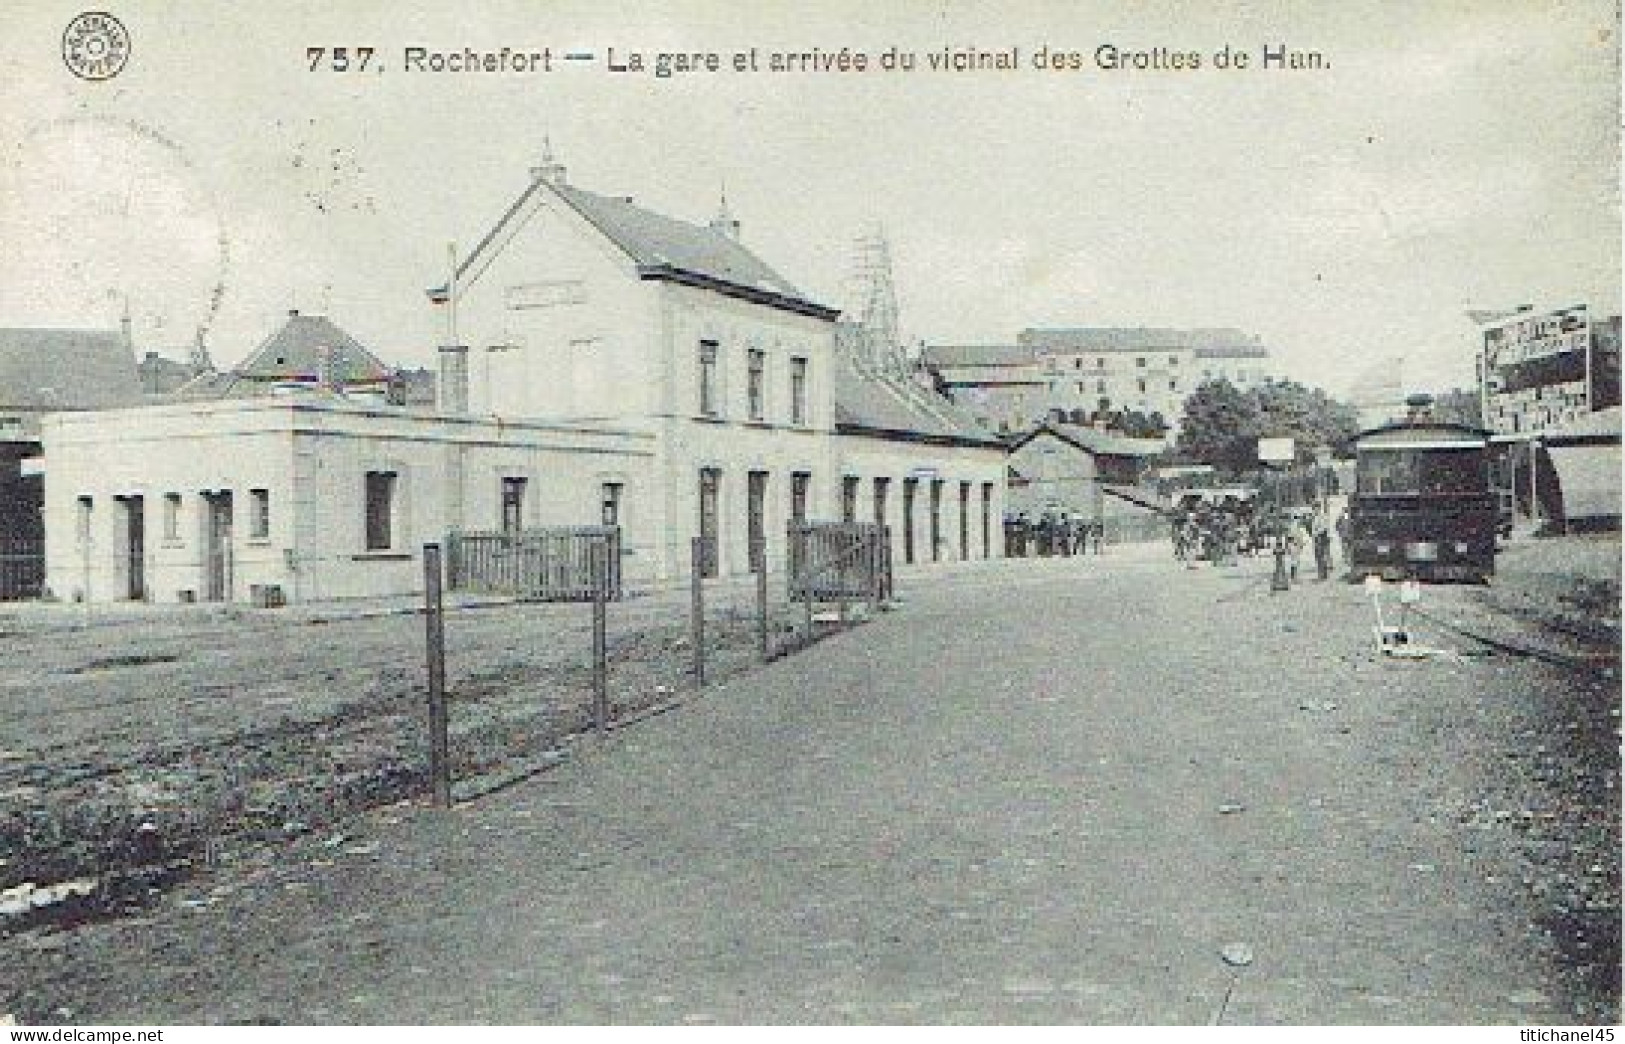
[{"x1": 0, "y1": 540, "x2": 1620, "y2": 1023}]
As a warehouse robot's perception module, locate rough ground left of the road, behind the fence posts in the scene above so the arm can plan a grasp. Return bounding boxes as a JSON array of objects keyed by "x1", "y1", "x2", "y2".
[{"x1": 0, "y1": 577, "x2": 827, "y2": 932}]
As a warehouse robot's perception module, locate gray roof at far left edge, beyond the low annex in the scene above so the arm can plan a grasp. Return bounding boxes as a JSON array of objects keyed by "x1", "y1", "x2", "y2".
[{"x1": 0, "y1": 328, "x2": 141, "y2": 413}]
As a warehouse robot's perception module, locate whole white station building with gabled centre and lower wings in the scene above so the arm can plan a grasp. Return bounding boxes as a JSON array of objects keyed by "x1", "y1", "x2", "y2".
[{"x1": 44, "y1": 161, "x2": 1006, "y2": 602}]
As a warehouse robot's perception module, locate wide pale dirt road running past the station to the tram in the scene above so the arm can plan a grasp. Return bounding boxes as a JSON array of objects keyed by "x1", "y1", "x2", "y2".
[{"x1": 5, "y1": 539, "x2": 1619, "y2": 1024}]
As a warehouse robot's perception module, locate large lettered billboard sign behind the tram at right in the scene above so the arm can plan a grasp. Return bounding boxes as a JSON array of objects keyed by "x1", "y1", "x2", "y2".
[{"x1": 1479, "y1": 304, "x2": 1591, "y2": 434}]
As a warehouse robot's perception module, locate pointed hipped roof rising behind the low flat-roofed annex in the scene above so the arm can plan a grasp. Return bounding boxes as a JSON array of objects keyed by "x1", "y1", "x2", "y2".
[{"x1": 177, "y1": 311, "x2": 393, "y2": 398}]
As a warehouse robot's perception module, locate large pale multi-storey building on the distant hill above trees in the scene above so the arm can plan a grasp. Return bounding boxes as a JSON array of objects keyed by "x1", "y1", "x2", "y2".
[{"x1": 923, "y1": 327, "x2": 1269, "y2": 437}]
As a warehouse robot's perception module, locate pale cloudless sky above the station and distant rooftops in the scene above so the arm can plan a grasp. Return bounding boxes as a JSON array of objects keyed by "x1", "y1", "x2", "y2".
[{"x1": 0, "y1": 0, "x2": 1620, "y2": 392}]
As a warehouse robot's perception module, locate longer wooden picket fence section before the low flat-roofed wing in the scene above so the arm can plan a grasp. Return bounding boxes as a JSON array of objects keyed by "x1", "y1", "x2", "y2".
[{"x1": 445, "y1": 525, "x2": 621, "y2": 602}]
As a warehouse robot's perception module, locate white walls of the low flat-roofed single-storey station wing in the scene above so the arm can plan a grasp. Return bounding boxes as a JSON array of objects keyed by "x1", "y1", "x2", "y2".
[{"x1": 46, "y1": 400, "x2": 663, "y2": 602}]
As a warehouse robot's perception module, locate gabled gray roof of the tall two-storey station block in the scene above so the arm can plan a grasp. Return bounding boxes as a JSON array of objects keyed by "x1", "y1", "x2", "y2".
[{"x1": 457, "y1": 177, "x2": 837, "y2": 319}]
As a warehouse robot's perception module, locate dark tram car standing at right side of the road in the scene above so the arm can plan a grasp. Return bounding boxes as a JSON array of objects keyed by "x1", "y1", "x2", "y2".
[{"x1": 1349, "y1": 420, "x2": 1498, "y2": 582}]
